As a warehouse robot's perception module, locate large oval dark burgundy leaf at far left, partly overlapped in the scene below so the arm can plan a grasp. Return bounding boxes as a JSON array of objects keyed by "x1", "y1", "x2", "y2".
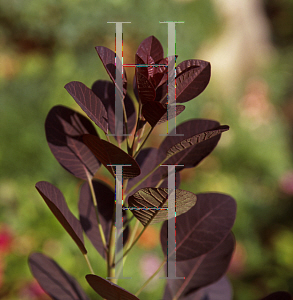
[{"x1": 45, "y1": 105, "x2": 100, "y2": 180}]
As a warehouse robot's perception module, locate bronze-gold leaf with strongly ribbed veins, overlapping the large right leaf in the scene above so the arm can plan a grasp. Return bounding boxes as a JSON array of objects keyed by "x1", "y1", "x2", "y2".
[{"x1": 128, "y1": 188, "x2": 196, "y2": 226}]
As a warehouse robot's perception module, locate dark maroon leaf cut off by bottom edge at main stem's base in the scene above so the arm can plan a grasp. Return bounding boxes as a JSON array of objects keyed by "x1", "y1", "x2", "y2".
[{"x1": 85, "y1": 274, "x2": 139, "y2": 300}]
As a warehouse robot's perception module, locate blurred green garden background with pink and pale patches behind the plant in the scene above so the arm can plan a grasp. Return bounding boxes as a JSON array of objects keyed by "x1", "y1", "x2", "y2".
[{"x1": 0, "y1": 0, "x2": 293, "y2": 300}]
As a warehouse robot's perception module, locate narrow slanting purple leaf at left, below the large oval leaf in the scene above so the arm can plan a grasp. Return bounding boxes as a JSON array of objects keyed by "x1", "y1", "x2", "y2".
[{"x1": 36, "y1": 181, "x2": 87, "y2": 254}]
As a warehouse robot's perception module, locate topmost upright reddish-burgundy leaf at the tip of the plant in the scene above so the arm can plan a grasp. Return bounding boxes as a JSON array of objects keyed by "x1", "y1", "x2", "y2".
[{"x1": 135, "y1": 35, "x2": 164, "y2": 64}]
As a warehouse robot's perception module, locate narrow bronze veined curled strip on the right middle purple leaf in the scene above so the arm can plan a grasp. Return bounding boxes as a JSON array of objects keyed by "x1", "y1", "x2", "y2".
[{"x1": 167, "y1": 125, "x2": 229, "y2": 157}]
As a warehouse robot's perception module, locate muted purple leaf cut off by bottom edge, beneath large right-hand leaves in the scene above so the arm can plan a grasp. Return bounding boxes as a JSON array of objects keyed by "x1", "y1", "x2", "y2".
[{"x1": 163, "y1": 276, "x2": 233, "y2": 300}]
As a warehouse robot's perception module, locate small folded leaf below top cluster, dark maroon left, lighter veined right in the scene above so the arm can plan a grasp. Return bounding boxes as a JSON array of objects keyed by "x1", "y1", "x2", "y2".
[{"x1": 142, "y1": 101, "x2": 185, "y2": 127}]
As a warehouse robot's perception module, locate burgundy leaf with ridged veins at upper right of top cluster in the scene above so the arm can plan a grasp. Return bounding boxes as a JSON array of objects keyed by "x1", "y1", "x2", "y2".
[{"x1": 176, "y1": 59, "x2": 211, "y2": 103}]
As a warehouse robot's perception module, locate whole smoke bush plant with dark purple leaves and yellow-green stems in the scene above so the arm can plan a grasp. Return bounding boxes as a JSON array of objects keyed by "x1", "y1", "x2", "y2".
[{"x1": 29, "y1": 36, "x2": 290, "y2": 300}]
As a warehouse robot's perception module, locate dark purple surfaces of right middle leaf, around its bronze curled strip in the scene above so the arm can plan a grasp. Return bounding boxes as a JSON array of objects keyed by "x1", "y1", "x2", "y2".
[{"x1": 157, "y1": 119, "x2": 221, "y2": 176}]
